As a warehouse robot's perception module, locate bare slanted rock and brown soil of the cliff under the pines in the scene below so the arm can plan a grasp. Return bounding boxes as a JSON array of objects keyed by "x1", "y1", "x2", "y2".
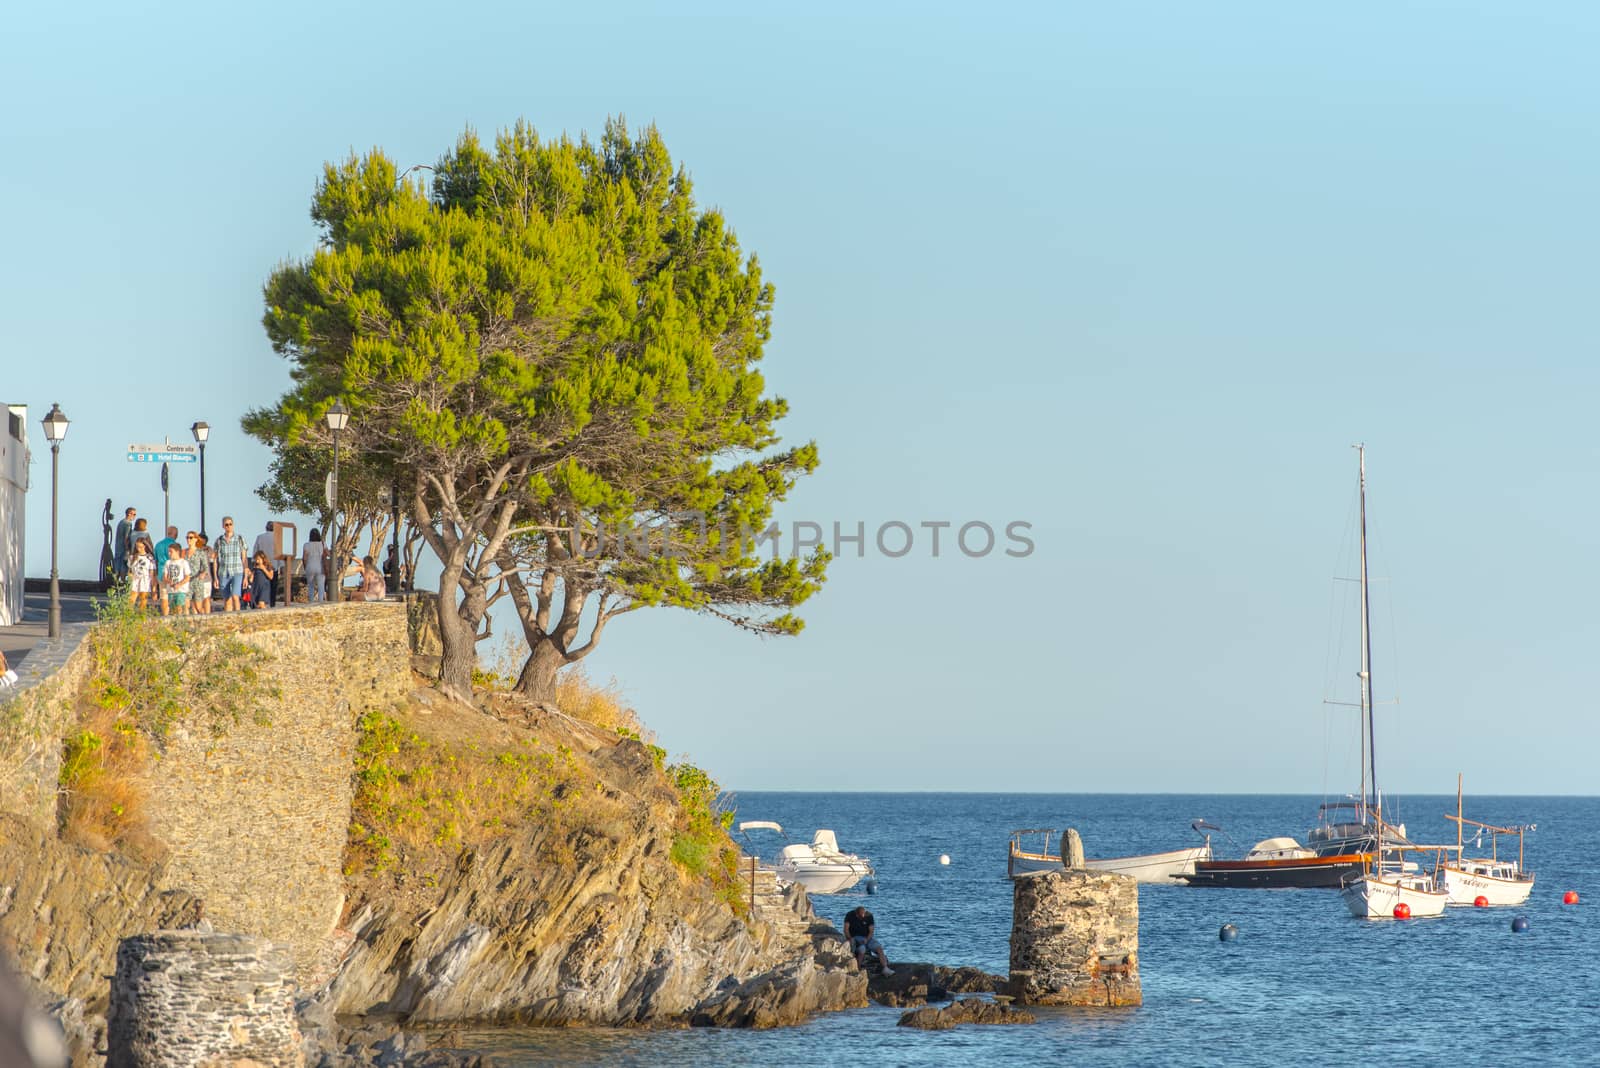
[{"x1": 326, "y1": 687, "x2": 866, "y2": 1026}]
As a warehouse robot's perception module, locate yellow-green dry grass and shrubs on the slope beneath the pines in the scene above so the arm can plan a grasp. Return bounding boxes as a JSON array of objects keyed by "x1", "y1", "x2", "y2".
[{"x1": 346, "y1": 679, "x2": 746, "y2": 915}]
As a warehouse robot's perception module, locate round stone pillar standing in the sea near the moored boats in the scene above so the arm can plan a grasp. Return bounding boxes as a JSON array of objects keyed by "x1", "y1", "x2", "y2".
[{"x1": 1006, "y1": 868, "x2": 1144, "y2": 1006}]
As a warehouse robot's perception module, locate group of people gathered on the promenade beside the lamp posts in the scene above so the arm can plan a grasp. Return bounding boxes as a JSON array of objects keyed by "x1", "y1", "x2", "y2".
[{"x1": 112, "y1": 507, "x2": 387, "y2": 616}]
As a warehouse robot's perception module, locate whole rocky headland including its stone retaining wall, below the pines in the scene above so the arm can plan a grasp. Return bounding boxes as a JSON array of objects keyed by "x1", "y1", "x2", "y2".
[{"x1": 0, "y1": 604, "x2": 866, "y2": 1052}]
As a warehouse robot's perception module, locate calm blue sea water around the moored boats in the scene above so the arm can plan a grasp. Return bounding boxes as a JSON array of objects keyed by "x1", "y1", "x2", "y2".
[{"x1": 457, "y1": 793, "x2": 1600, "y2": 1068}]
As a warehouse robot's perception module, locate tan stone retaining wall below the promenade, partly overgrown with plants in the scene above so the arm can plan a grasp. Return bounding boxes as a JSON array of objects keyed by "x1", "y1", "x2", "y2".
[{"x1": 0, "y1": 601, "x2": 411, "y2": 978}]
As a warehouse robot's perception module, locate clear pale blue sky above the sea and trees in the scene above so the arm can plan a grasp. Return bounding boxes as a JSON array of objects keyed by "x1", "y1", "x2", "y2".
[{"x1": 0, "y1": 2, "x2": 1600, "y2": 793}]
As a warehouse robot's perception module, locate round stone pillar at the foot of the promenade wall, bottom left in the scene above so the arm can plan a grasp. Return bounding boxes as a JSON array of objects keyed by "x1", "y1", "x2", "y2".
[{"x1": 106, "y1": 931, "x2": 306, "y2": 1068}]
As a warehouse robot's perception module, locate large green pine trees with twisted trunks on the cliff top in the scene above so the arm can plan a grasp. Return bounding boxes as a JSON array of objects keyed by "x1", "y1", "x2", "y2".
[{"x1": 245, "y1": 118, "x2": 827, "y2": 691}]
